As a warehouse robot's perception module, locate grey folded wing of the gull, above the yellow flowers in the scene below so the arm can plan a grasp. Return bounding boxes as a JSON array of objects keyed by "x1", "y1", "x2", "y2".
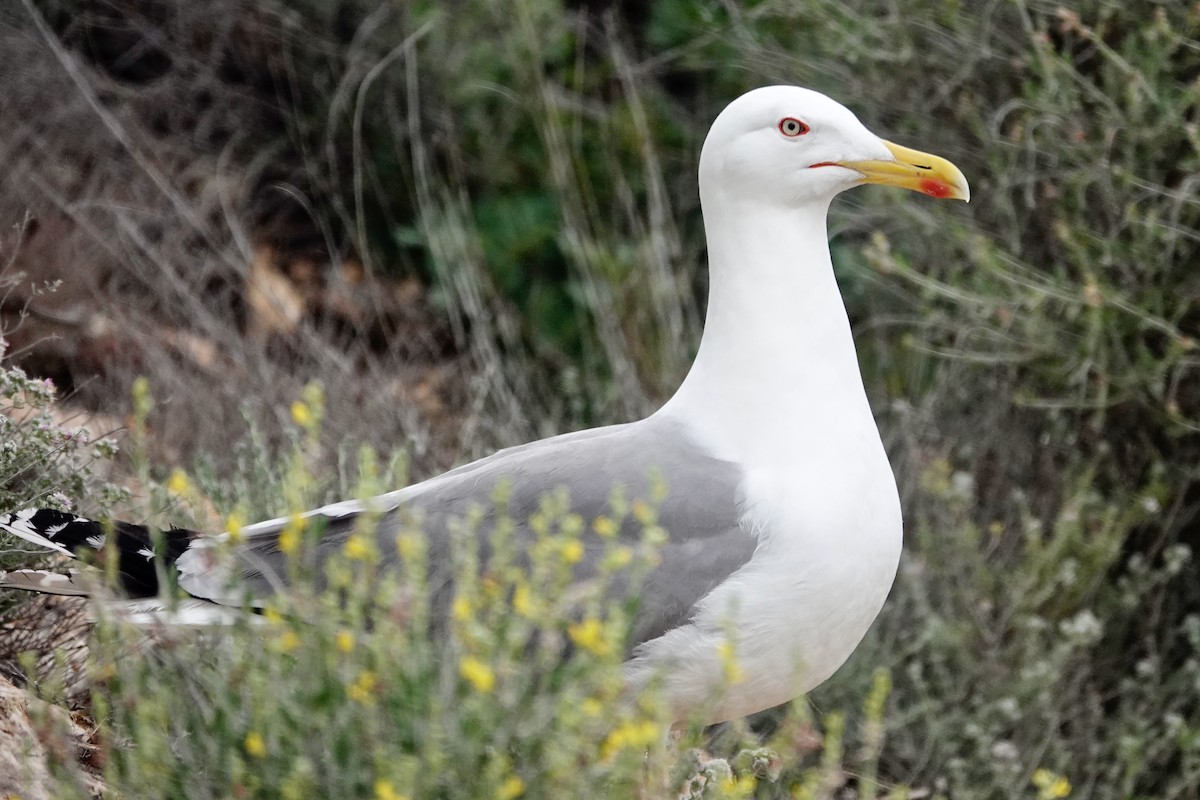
[{"x1": 179, "y1": 416, "x2": 757, "y2": 646}]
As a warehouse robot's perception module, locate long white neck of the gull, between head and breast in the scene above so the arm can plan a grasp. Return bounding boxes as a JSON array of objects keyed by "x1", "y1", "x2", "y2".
[{"x1": 662, "y1": 187, "x2": 878, "y2": 461}]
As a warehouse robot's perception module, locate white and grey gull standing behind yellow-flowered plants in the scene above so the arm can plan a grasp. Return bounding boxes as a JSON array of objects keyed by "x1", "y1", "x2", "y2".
[{"x1": 0, "y1": 86, "x2": 970, "y2": 723}]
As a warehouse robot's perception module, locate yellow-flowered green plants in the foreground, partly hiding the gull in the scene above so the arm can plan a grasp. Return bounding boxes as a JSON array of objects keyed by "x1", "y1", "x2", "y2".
[{"x1": 60, "y1": 400, "x2": 901, "y2": 800}]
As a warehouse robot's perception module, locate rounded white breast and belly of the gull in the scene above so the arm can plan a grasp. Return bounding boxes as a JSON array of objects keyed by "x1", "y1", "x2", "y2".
[{"x1": 626, "y1": 428, "x2": 901, "y2": 722}]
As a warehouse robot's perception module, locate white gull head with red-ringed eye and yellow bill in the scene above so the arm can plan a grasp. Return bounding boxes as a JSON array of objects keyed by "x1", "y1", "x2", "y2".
[{"x1": 700, "y1": 86, "x2": 971, "y2": 206}]
